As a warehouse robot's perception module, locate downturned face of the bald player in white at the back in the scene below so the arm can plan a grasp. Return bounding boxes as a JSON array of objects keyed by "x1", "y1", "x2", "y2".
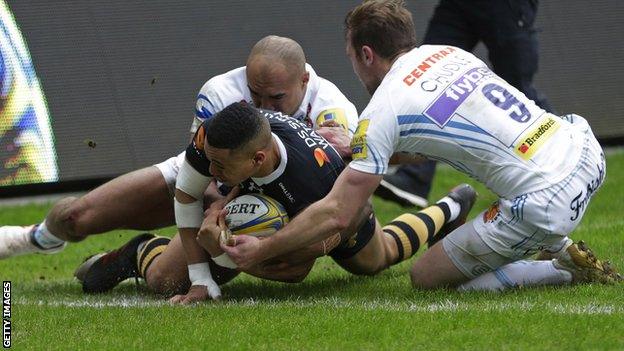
[{"x1": 247, "y1": 63, "x2": 310, "y2": 115}]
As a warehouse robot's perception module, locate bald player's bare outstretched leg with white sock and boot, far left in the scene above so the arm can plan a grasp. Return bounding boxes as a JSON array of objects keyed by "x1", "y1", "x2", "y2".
[{"x1": 0, "y1": 153, "x2": 184, "y2": 258}]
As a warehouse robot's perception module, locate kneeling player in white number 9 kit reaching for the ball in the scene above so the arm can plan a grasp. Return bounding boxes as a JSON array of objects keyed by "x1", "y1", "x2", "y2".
[{"x1": 223, "y1": 0, "x2": 621, "y2": 290}]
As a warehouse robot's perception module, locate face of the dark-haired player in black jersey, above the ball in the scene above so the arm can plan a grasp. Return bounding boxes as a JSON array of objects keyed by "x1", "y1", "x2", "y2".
[{"x1": 204, "y1": 144, "x2": 258, "y2": 186}]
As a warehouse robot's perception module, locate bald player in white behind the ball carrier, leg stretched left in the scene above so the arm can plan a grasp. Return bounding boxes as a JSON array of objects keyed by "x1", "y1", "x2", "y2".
[{"x1": 0, "y1": 36, "x2": 357, "y2": 259}]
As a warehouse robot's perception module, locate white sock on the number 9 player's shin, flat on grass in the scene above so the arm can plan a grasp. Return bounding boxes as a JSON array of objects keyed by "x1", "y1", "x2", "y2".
[{"x1": 457, "y1": 260, "x2": 572, "y2": 291}]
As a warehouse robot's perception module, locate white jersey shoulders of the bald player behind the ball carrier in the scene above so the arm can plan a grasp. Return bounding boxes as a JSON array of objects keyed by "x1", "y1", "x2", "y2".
[{"x1": 191, "y1": 63, "x2": 358, "y2": 136}]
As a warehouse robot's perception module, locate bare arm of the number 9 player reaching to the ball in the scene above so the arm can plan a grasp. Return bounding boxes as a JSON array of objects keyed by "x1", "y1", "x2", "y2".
[{"x1": 221, "y1": 168, "x2": 382, "y2": 269}]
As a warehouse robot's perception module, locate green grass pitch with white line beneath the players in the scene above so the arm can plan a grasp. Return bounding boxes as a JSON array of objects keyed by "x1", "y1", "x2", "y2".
[{"x1": 0, "y1": 153, "x2": 624, "y2": 350}]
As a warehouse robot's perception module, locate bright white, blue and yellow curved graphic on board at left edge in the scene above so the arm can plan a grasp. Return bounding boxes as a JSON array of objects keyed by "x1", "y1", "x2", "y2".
[{"x1": 0, "y1": 0, "x2": 58, "y2": 186}]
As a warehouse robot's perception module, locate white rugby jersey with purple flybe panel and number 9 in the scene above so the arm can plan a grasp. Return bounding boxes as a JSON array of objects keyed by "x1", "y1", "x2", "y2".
[{"x1": 349, "y1": 45, "x2": 583, "y2": 198}]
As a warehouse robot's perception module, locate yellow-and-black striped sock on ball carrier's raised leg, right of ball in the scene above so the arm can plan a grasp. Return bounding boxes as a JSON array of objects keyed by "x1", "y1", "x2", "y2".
[{"x1": 382, "y1": 205, "x2": 448, "y2": 263}]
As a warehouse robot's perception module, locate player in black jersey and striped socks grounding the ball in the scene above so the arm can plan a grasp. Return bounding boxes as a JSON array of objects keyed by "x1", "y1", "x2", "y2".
[{"x1": 78, "y1": 103, "x2": 476, "y2": 303}]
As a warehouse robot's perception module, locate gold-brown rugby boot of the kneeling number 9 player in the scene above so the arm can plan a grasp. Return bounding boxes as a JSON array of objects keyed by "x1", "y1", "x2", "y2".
[{"x1": 553, "y1": 240, "x2": 624, "y2": 284}]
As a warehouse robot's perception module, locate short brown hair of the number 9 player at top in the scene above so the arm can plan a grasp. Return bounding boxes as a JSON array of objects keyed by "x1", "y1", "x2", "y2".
[{"x1": 344, "y1": 0, "x2": 417, "y2": 60}]
